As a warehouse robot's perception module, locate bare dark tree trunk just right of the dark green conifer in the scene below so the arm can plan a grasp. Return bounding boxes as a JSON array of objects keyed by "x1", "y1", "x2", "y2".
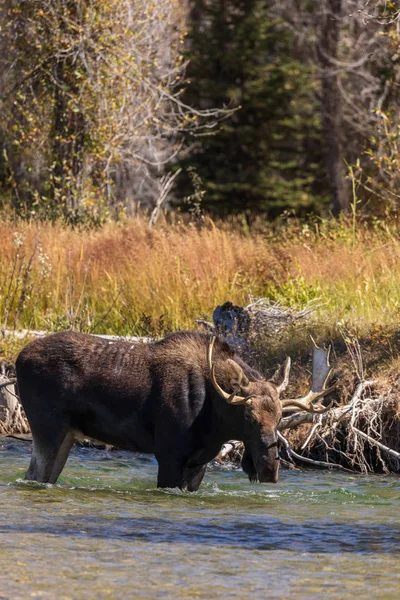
[{"x1": 317, "y1": 0, "x2": 350, "y2": 216}]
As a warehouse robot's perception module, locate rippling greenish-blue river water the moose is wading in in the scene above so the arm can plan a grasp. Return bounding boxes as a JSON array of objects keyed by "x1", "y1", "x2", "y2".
[{"x1": 0, "y1": 438, "x2": 400, "y2": 600}]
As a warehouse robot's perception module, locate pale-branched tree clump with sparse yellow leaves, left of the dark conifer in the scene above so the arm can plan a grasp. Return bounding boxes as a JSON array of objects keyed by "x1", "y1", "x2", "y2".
[{"x1": 0, "y1": 0, "x2": 190, "y2": 225}]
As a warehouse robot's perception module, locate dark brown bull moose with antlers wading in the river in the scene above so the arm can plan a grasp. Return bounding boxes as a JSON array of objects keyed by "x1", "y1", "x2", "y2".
[{"x1": 16, "y1": 331, "x2": 330, "y2": 491}]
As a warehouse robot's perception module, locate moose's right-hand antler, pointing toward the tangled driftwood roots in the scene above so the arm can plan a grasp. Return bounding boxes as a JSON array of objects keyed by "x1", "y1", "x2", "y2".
[{"x1": 281, "y1": 338, "x2": 336, "y2": 414}]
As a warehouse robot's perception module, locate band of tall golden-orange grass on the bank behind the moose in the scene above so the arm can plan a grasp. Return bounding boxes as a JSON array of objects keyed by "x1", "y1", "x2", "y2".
[{"x1": 0, "y1": 218, "x2": 400, "y2": 344}]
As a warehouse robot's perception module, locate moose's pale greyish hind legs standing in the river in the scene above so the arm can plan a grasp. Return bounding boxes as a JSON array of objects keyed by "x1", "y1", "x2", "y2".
[{"x1": 25, "y1": 431, "x2": 74, "y2": 483}]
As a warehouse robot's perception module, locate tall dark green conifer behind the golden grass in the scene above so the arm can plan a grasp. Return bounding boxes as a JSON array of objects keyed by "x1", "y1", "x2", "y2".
[{"x1": 181, "y1": 0, "x2": 328, "y2": 215}]
